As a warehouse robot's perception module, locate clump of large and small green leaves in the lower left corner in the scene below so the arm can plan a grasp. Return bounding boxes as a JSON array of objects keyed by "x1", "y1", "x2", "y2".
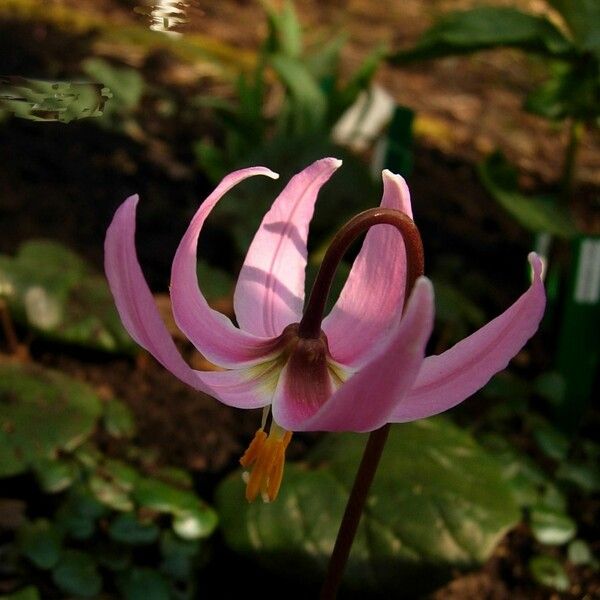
[{"x1": 0, "y1": 363, "x2": 217, "y2": 600}]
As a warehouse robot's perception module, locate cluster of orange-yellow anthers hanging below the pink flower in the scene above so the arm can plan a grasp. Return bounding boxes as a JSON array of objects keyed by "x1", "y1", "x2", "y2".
[{"x1": 240, "y1": 423, "x2": 292, "y2": 502}]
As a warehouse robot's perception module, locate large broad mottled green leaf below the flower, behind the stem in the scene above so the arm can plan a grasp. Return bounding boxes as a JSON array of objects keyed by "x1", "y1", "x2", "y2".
[{"x1": 216, "y1": 418, "x2": 519, "y2": 597}]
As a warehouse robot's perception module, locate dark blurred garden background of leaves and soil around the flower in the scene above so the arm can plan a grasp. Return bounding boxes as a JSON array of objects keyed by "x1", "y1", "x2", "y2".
[{"x1": 0, "y1": 0, "x2": 600, "y2": 600}]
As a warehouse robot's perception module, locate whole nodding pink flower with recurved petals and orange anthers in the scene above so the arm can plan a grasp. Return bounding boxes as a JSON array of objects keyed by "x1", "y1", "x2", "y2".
[{"x1": 105, "y1": 158, "x2": 545, "y2": 500}]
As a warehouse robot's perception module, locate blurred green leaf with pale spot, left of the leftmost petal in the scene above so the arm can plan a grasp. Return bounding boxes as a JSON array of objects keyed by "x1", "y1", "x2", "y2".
[{"x1": 0, "y1": 240, "x2": 135, "y2": 352}]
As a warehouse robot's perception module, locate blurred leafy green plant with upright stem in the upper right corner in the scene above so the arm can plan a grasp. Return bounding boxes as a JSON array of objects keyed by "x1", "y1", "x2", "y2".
[{"x1": 390, "y1": 0, "x2": 600, "y2": 230}]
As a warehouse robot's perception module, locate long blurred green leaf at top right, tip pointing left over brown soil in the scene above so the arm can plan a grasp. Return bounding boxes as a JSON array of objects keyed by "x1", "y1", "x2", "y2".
[{"x1": 391, "y1": 6, "x2": 574, "y2": 63}]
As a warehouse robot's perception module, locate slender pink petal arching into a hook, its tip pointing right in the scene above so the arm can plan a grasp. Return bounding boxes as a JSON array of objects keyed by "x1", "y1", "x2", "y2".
[{"x1": 171, "y1": 167, "x2": 278, "y2": 368}]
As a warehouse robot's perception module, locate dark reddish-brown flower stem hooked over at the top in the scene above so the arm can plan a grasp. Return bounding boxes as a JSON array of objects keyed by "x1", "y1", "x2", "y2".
[{"x1": 298, "y1": 207, "x2": 424, "y2": 600}]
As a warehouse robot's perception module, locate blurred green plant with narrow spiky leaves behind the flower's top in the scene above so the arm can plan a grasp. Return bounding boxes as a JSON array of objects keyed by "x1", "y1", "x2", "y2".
[{"x1": 196, "y1": 0, "x2": 385, "y2": 180}]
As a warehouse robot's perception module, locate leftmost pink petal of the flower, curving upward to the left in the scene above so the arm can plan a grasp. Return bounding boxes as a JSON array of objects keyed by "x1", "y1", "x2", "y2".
[{"x1": 104, "y1": 195, "x2": 271, "y2": 408}]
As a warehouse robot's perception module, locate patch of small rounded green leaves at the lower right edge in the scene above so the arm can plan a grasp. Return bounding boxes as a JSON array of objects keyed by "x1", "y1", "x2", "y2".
[{"x1": 477, "y1": 372, "x2": 600, "y2": 591}]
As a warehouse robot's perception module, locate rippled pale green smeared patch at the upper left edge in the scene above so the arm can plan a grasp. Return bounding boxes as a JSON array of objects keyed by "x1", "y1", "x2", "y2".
[{"x1": 0, "y1": 76, "x2": 112, "y2": 123}]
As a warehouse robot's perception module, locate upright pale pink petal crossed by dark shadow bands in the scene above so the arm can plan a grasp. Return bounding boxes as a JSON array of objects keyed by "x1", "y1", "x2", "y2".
[{"x1": 233, "y1": 158, "x2": 341, "y2": 337}]
